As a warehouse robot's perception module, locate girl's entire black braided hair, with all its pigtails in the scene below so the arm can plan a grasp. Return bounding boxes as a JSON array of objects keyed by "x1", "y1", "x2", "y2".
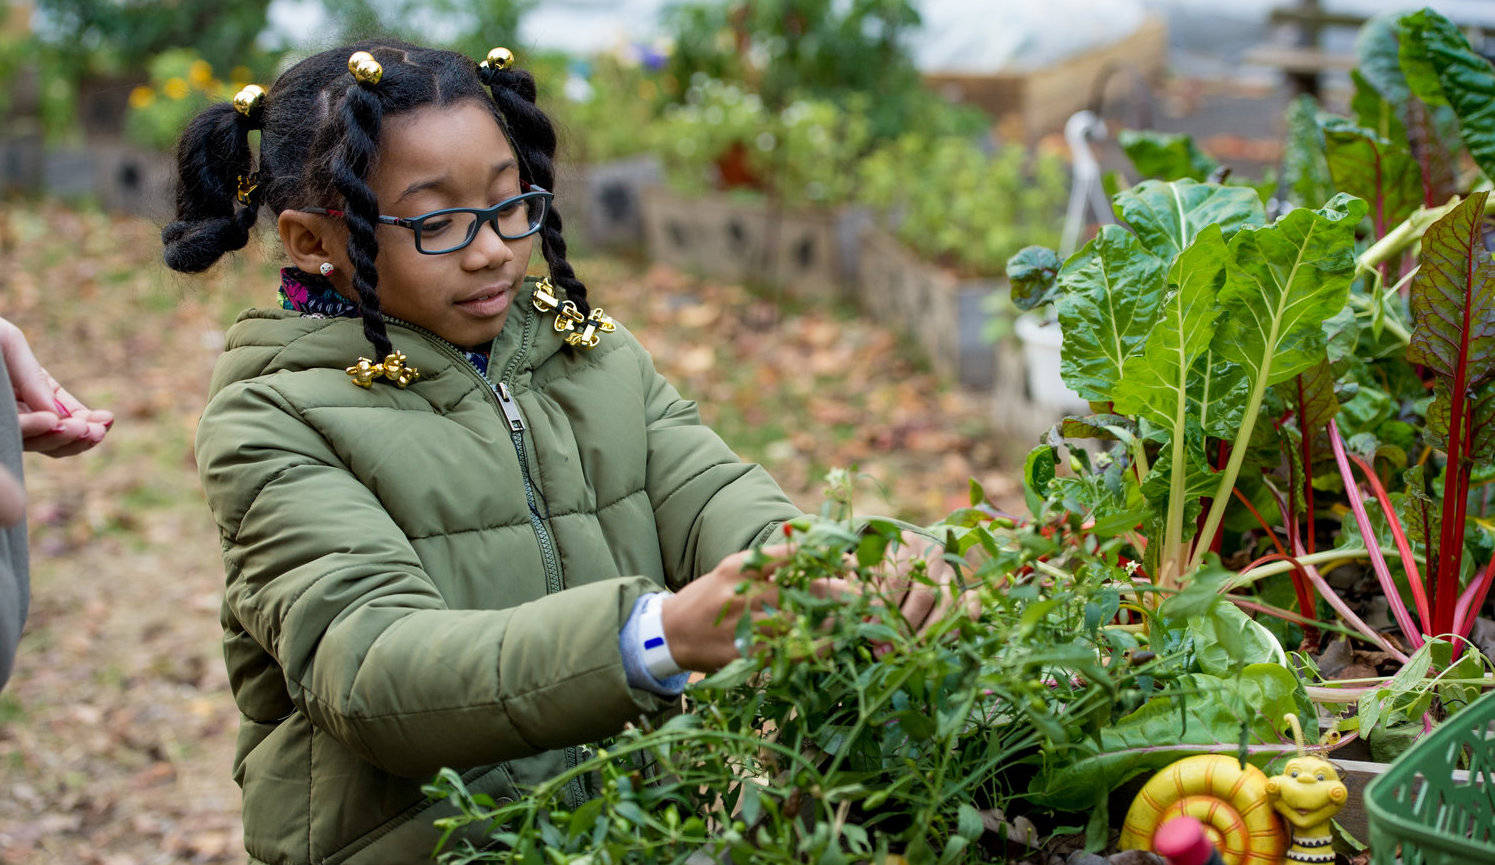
[{"x1": 161, "y1": 39, "x2": 591, "y2": 357}]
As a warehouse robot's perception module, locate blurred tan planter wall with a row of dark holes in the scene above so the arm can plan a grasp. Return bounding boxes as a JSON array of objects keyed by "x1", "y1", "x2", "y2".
[{"x1": 643, "y1": 187, "x2": 846, "y2": 297}]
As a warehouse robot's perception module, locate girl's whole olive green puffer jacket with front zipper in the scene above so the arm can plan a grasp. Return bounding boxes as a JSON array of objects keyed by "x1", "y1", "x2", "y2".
[{"x1": 197, "y1": 282, "x2": 798, "y2": 865}]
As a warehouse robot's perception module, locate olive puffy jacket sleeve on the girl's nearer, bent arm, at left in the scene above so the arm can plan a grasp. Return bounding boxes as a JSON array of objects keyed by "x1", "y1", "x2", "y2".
[{"x1": 197, "y1": 379, "x2": 662, "y2": 777}]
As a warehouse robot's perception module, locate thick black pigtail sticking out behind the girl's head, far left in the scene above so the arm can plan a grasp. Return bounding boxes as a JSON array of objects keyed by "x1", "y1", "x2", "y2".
[{"x1": 161, "y1": 102, "x2": 259, "y2": 273}]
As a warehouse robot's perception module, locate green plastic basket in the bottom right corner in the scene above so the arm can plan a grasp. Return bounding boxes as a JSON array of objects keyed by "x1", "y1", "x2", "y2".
[{"x1": 1365, "y1": 692, "x2": 1495, "y2": 865}]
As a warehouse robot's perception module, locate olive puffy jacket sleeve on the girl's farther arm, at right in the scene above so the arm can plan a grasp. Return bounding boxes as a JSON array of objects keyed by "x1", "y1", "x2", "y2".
[{"x1": 638, "y1": 340, "x2": 801, "y2": 589}]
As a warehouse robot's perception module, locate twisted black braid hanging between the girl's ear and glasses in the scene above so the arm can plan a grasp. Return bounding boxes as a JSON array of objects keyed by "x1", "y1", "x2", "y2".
[{"x1": 326, "y1": 77, "x2": 393, "y2": 359}]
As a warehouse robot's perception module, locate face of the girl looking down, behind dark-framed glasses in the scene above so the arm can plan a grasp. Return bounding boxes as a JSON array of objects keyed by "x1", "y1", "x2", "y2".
[{"x1": 369, "y1": 102, "x2": 535, "y2": 347}]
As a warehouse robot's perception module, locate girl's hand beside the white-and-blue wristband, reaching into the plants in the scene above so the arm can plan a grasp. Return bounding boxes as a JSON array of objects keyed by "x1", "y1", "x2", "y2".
[{"x1": 659, "y1": 544, "x2": 854, "y2": 672}]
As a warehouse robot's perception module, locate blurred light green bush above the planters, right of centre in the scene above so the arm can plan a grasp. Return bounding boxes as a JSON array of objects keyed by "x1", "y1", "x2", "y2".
[{"x1": 857, "y1": 130, "x2": 1069, "y2": 275}]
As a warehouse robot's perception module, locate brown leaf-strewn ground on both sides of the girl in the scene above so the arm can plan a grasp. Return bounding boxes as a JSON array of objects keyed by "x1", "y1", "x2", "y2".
[{"x1": 0, "y1": 202, "x2": 1018, "y2": 865}]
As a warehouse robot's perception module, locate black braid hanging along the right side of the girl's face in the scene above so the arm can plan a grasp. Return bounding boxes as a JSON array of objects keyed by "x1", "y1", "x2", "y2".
[{"x1": 478, "y1": 64, "x2": 592, "y2": 315}]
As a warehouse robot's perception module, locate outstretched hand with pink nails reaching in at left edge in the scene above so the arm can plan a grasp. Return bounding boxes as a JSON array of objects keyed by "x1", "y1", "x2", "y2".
[{"x1": 0, "y1": 318, "x2": 114, "y2": 457}]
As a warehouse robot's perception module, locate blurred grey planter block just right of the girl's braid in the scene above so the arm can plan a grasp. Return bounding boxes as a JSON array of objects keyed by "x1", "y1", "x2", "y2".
[{"x1": 555, "y1": 154, "x2": 664, "y2": 251}]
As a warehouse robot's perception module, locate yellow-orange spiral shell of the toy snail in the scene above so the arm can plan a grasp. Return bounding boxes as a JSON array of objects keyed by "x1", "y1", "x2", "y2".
[{"x1": 1120, "y1": 754, "x2": 1287, "y2": 865}]
